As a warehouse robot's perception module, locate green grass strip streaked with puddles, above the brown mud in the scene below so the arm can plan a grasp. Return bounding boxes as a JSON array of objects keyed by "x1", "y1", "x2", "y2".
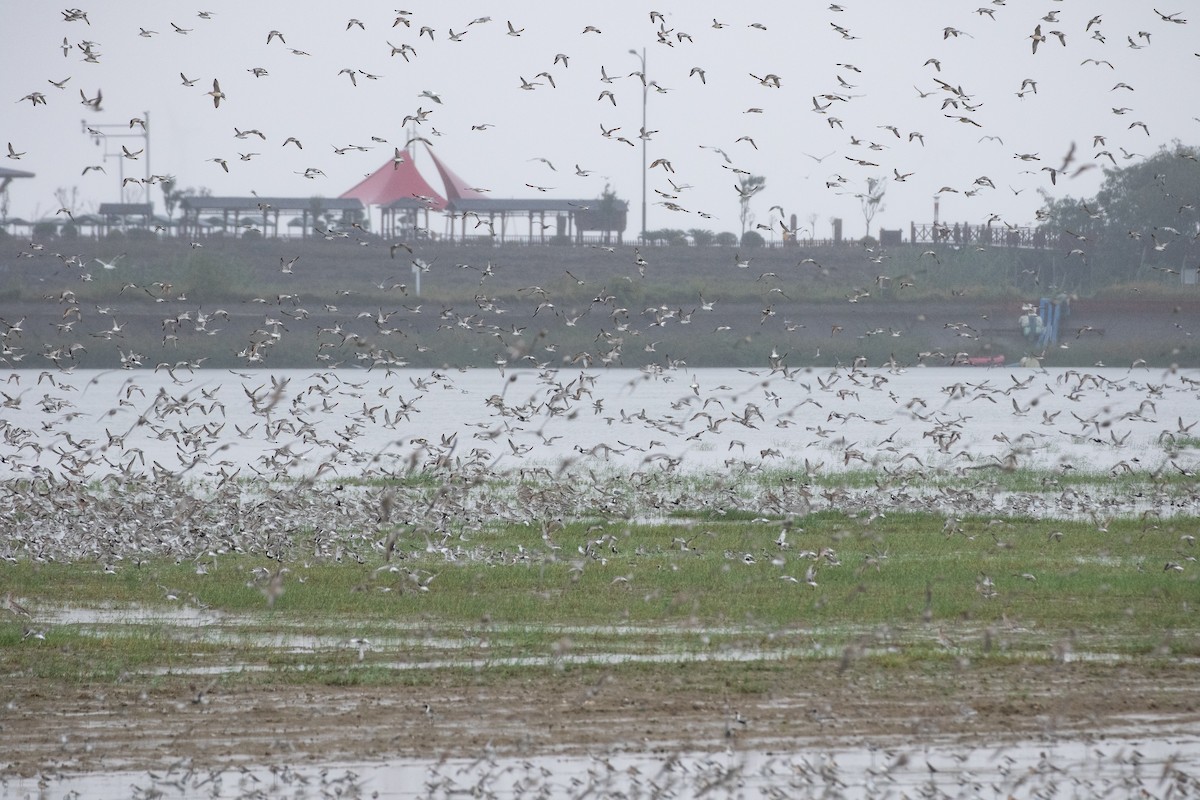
[{"x1": 0, "y1": 511, "x2": 1200, "y2": 684}]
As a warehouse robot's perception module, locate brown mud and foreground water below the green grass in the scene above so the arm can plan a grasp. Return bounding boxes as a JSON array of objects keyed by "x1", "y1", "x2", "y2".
[{"x1": 4, "y1": 662, "x2": 1200, "y2": 798}]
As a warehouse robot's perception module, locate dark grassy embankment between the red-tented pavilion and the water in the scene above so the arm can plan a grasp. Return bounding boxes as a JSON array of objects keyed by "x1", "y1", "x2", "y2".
[{"x1": 0, "y1": 240, "x2": 1196, "y2": 367}]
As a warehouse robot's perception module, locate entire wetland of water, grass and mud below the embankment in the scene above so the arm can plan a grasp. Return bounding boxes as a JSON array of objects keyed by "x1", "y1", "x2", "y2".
[{"x1": 0, "y1": 369, "x2": 1200, "y2": 798}]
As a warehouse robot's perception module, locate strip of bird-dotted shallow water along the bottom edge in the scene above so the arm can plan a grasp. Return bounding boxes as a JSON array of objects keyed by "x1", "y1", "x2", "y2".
[{"x1": 9, "y1": 734, "x2": 1200, "y2": 800}]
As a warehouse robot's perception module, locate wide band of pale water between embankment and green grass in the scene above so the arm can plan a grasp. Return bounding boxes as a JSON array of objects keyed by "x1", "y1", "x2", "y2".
[{"x1": 0, "y1": 367, "x2": 1200, "y2": 479}]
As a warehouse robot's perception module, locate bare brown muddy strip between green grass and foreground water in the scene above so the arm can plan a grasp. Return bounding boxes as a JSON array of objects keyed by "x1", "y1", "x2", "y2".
[{"x1": 0, "y1": 662, "x2": 1200, "y2": 777}]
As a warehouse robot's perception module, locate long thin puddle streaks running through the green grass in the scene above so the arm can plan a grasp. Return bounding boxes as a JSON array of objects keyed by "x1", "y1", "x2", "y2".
[{"x1": 38, "y1": 604, "x2": 1200, "y2": 675}]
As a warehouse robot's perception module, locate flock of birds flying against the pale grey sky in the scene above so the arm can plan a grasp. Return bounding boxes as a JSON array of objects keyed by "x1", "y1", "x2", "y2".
[{"x1": 8, "y1": 0, "x2": 1188, "y2": 235}]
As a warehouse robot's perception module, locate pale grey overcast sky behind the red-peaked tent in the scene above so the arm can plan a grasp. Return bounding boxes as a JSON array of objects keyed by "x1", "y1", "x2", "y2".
[{"x1": 0, "y1": 0, "x2": 1200, "y2": 236}]
